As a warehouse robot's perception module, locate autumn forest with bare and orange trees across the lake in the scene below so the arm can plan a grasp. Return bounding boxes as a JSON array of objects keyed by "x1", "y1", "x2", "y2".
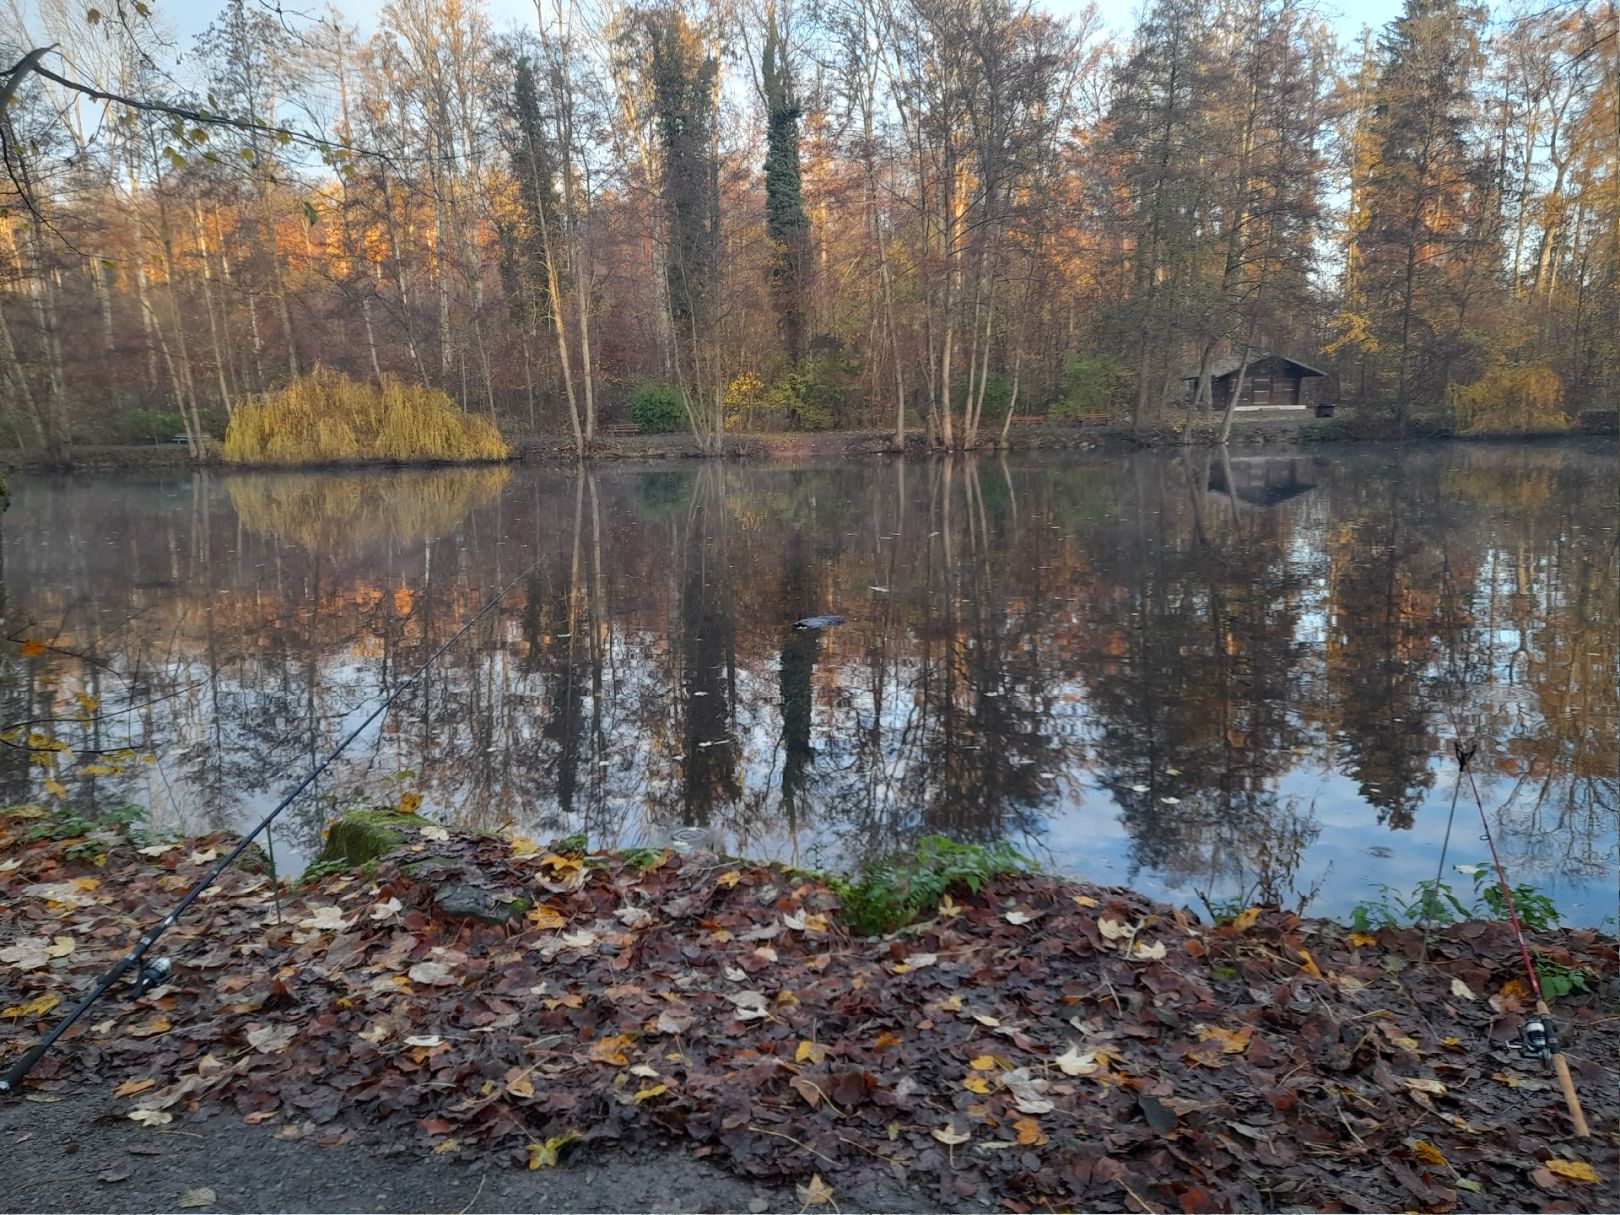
[{"x1": 0, "y1": 0, "x2": 1620, "y2": 462}]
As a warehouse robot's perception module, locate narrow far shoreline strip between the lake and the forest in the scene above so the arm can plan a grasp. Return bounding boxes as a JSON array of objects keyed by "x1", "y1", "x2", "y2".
[{"x1": 0, "y1": 418, "x2": 1614, "y2": 473}]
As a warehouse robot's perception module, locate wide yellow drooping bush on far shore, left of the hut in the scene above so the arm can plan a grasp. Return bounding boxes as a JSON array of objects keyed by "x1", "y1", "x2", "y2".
[{"x1": 225, "y1": 368, "x2": 509, "y2": 463}]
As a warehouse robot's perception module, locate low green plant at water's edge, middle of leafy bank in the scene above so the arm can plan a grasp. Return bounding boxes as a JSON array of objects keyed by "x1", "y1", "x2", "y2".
[{"x1": 828, "y1": 836, "x2": 1034, "y2": 936}]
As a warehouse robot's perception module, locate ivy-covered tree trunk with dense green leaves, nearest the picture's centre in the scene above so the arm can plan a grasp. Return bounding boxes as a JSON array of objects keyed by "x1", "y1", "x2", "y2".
[{"x1": 760, "y1": 3, "x2": 810, "y2": 363}]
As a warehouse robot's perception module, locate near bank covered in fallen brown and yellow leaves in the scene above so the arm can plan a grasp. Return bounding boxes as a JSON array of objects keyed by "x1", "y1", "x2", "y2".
[{"x1": 0, "y1": 815, "x2": 1620, "y2": 1210}]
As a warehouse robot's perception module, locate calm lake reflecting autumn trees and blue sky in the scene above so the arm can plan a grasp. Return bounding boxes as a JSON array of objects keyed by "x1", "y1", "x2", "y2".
[{"x1": 0, "y1": 444, "x2": 1620, "y2": 930}]
